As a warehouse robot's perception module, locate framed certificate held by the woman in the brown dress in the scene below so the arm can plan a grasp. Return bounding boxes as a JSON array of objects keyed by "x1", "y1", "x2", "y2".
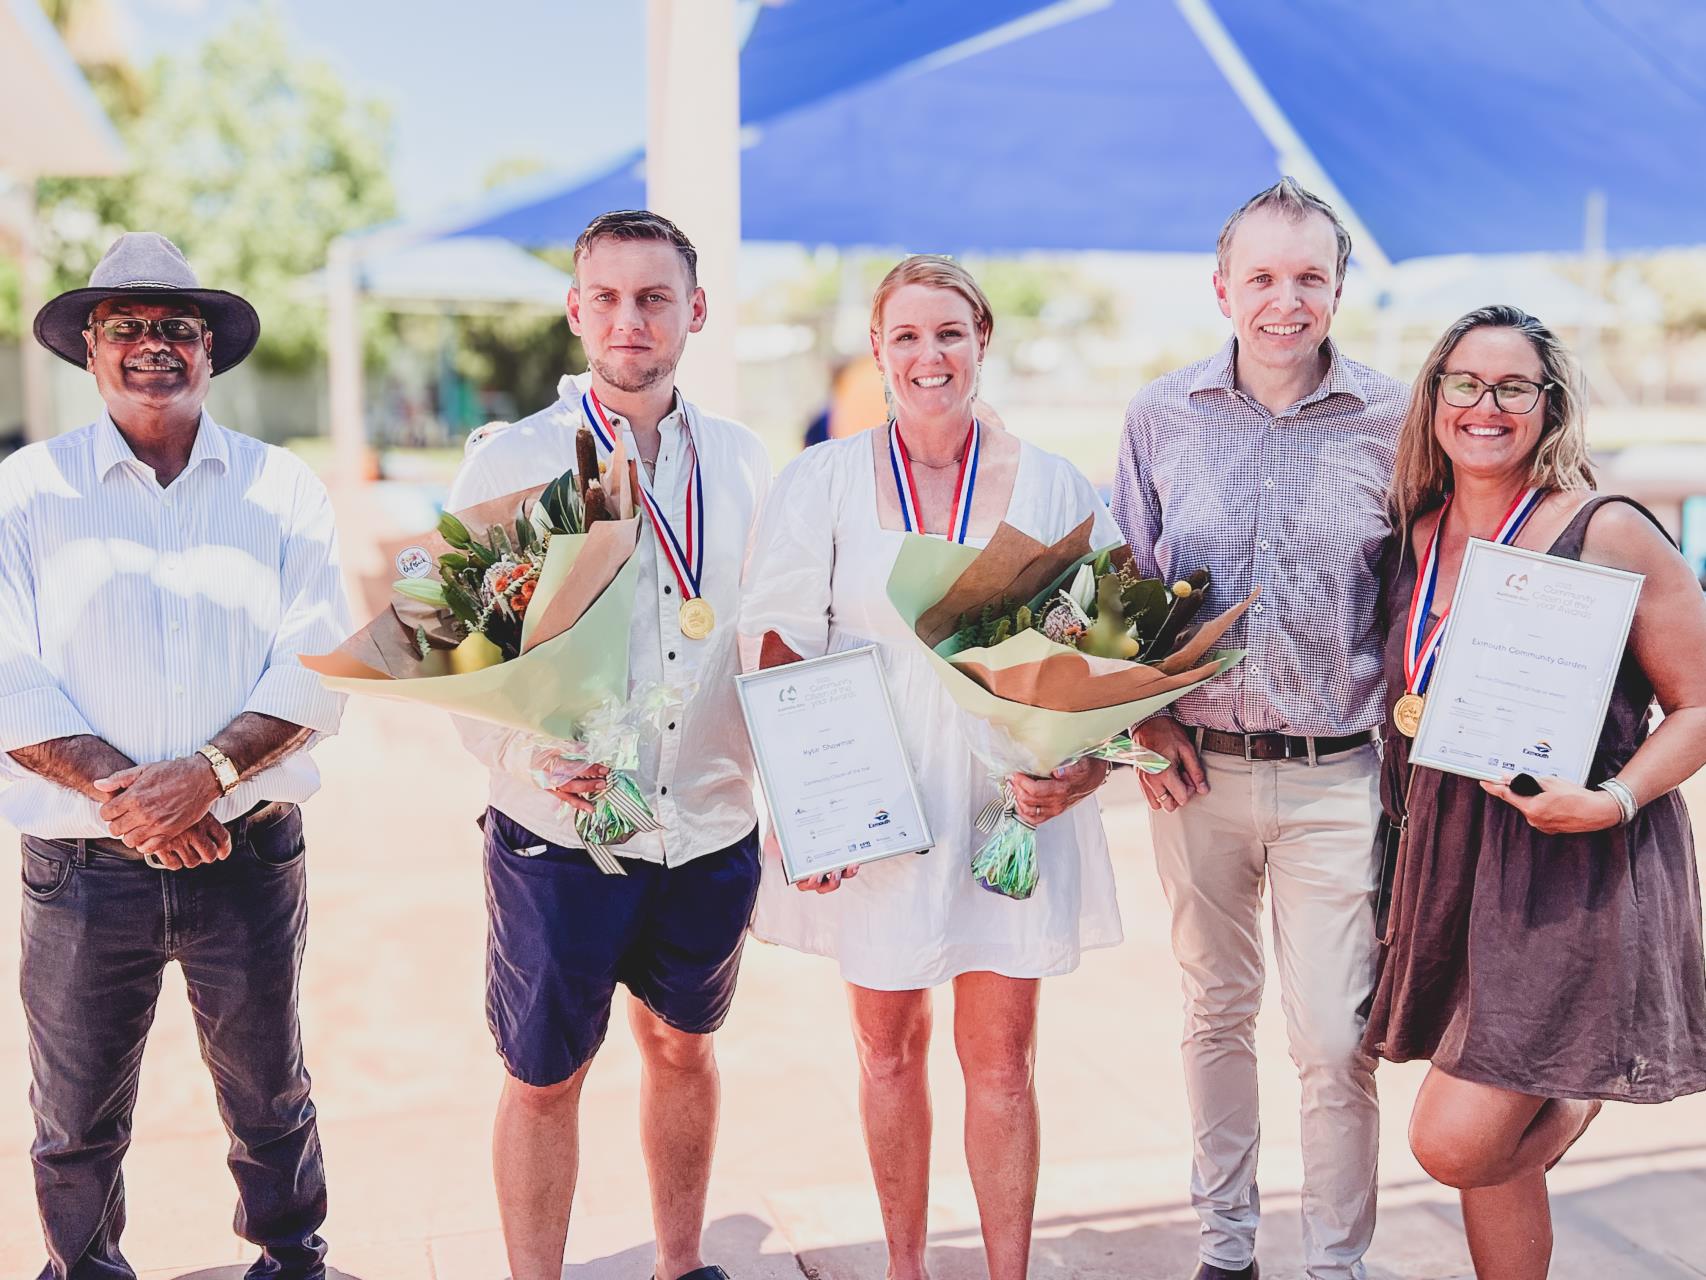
[{"x1": 1409, "y1": 538, "x2": 1645, "y2": 785}]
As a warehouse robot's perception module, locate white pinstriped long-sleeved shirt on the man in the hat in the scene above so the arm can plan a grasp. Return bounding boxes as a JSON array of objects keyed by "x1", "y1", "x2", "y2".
[{"x1": 0, "y1": 413, "x2": 350, "y2": 840}]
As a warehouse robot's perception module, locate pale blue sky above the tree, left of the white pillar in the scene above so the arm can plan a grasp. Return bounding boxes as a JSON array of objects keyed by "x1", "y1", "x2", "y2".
[{"x1": 119, "y1": 0, "x2": 647, "y2": 217}]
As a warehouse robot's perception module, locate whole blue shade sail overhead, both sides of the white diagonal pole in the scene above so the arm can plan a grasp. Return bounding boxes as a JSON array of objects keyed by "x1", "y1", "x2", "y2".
[{"x1": 433, "y1": 0, "x2": 1706, "y2": 259}]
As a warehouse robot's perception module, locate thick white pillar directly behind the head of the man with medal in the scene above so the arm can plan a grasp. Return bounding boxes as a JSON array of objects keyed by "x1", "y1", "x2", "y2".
[{"x1": 647, "y1": 0, "x2": 740, "y2": 415}]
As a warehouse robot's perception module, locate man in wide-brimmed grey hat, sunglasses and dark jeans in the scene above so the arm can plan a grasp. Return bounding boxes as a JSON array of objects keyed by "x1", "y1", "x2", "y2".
[{"x1": 0, "y1": 232, "x2": 350, "y2": 1280}]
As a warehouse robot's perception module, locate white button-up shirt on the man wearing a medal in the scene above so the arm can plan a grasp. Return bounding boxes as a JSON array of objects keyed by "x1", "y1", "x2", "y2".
[{"x1": 447, "y1": 374, "x2": 771, "y2": 867}]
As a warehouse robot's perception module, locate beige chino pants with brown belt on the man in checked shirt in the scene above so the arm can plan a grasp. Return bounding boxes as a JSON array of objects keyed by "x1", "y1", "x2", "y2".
[{"x1": 1152, "y1": 746, "x2": 1380, "y2": 1280}]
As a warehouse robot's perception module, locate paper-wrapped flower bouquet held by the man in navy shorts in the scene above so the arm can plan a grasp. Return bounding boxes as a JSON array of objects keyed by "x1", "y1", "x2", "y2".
[{"x1": 302, "y1": 428, "x2": 669, "y2": 874}]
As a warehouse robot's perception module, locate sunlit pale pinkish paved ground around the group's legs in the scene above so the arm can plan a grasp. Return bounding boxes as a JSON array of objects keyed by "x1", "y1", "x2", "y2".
[{"x1": 0, "y1": 701, "x2": 1706, "y2": 1280}]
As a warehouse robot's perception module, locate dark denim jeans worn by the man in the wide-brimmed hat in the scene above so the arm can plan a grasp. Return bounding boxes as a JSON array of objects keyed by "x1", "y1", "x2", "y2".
[{"x1": 20, "y1": 806, "x2": 326, "y2": 1280}]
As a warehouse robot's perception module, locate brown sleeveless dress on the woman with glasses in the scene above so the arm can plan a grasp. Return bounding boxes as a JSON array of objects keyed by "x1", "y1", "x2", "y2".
[{"x1": 1363, "y1": 497, "x2": 1706, "y2": 1103}]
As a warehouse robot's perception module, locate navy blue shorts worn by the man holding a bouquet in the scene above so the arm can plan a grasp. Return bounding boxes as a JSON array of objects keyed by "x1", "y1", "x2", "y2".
[{"x1": 485, "y1": 809, "x2": 759, "y2": 1085}]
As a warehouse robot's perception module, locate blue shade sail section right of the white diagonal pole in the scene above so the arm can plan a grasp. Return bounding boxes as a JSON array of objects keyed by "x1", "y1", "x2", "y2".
[{"x1": 1215, "y1": 0, "x2": 1706, "y2": 258}]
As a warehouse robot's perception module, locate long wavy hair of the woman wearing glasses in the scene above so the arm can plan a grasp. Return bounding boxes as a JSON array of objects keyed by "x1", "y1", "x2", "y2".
[{"x1": 1390, "y1": 305, "x2": 1599, "y2": 536}]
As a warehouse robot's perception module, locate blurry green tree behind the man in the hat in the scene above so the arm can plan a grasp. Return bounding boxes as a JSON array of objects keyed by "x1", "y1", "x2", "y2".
[{"x1": 27, "y1": 5, "x2": 394, "y2": 369}]
